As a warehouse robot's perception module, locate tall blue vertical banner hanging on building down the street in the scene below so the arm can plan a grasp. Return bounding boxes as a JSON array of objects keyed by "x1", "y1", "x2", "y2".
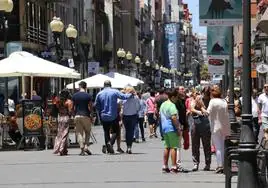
[{"x1": 164, "y1": 23, "x2": 180, "y2": 69}]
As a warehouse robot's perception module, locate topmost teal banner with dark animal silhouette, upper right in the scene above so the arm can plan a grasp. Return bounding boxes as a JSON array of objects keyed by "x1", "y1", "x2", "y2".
[{"x1": 199, "y1": 0, "x2": 243, "y2": 26}]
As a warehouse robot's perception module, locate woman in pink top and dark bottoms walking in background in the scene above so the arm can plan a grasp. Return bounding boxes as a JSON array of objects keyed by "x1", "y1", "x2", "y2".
[{"x1": 146, "y1": 91, "x2": 157, "y2": 138}]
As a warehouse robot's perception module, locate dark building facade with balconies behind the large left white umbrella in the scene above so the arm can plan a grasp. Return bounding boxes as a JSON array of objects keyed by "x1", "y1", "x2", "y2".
[{"x1": 0, "y1": 0, "x2": 83, "y2": 101}]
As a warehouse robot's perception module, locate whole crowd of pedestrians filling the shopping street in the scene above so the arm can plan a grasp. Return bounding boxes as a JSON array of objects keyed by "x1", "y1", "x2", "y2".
[{"x1": 42, "y1": 81, "x2": 268, "y2": 173}]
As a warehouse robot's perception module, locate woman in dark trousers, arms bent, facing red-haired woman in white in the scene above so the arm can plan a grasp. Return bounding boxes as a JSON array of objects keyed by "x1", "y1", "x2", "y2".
[{"x1": 191, "y1": 91, "x2": 211, "y2": 171}]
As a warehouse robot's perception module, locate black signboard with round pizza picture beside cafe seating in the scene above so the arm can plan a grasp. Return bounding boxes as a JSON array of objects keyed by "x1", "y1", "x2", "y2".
[{"x1": 22, "y1": 100, "x2": 43, "y2": 137}]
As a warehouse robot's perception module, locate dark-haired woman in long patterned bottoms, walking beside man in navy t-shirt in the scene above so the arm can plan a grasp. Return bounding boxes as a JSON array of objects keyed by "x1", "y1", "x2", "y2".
[{"x1": 54, "y1": 90, "x2": 73, "y2": 156}]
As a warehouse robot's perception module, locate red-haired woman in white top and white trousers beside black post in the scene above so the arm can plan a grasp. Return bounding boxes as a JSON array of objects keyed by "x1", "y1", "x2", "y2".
[{"x1": 207, "y1": 88, "x2": 230, "y2": 173}]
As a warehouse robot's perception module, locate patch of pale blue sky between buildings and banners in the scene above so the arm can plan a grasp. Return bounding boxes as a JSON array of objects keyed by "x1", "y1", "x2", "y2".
[{"x1": 183, "y1": 0, "x2": 207, "y2": 34}]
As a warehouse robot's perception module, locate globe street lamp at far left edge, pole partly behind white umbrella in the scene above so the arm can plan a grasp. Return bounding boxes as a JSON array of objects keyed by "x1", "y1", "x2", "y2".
[{"x1": 0, "y1": 0, "x2": 14, "y2": 115}]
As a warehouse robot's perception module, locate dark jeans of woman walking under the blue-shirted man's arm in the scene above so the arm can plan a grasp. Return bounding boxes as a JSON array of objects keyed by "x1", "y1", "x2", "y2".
[{"x1": 123, "y1": 114, "x2": 138, "y2": 147}]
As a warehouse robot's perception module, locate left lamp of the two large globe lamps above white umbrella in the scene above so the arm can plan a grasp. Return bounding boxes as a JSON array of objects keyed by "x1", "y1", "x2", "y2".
[{"x1": 50, "y1": 17, "x2": 64, "y2": 91}]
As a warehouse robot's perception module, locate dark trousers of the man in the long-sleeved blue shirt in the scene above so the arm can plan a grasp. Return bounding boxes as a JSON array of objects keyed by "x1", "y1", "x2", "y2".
[{"x1": 101, "y1": 119, "x2": 120, "y2": 146}]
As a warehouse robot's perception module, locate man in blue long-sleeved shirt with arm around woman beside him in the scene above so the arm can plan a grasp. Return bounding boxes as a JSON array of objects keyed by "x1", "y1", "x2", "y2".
[{"x1": 95, "y1": 80, "x2": 132, "y2": 154}]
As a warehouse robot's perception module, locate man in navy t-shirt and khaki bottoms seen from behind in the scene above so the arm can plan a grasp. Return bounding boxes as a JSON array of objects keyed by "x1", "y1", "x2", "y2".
[{"x1": 73, "y1": 81, "x2": 92, "y2": 155}]
